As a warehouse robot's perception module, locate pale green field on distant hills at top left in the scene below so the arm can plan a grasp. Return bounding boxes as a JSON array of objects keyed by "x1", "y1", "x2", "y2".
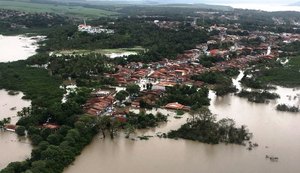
[{"x1": 0, "y1": 0, "x2": 117, "y2": 18}]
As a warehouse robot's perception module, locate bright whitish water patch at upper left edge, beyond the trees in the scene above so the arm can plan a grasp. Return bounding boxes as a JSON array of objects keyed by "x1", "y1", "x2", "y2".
[{"x1": 0, "y1": 35, "x2": 44, "y2": 62}]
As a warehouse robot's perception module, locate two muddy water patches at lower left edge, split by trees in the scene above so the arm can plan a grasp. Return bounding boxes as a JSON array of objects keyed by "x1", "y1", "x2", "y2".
[{"x1": 0, "y1": 90, "x2": 32, "y2": 170}]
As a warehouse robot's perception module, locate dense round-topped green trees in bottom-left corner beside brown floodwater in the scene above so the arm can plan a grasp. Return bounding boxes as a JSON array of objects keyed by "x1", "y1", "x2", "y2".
[{"x1": 1, "y1": 116, "x2": 96, "y2": 173}]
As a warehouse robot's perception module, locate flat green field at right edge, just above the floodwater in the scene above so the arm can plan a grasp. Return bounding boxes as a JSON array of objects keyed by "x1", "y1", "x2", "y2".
[{"x1": 259, "y1": 56, "x2": 300, "y2": 87}]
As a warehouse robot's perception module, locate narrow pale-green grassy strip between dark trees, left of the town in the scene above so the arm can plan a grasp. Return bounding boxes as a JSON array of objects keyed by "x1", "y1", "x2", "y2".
[{"x1": 54, "y1": 46, "x2": 146, "y2": 55}]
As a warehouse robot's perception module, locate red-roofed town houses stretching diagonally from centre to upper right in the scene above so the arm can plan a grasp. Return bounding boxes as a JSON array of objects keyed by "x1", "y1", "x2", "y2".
[{"x1": 81, "y1": 21, "x2": 300, "y2": 117}]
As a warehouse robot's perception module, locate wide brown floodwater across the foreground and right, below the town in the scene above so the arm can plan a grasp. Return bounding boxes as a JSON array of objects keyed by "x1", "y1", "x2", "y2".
[{"x1": 64, "y1": 74, "x2": 300, "y2": 173}]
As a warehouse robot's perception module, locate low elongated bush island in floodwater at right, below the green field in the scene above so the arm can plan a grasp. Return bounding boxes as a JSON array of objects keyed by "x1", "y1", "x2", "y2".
[{"x1": 237, "y1": 90, "x2": 280, "y2": 103}]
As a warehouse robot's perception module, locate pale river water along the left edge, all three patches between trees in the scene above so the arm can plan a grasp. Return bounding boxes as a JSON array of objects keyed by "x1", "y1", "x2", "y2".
[{"x1": 0, "y1": 35, "x2": 37, "y2": 170}]
